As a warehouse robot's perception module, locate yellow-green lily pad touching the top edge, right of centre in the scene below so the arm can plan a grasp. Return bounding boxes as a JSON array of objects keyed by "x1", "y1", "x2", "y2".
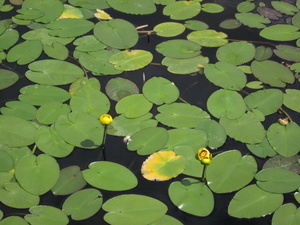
[{"x1": 163, "y1": 1, "x2": 201, "y2": 20}]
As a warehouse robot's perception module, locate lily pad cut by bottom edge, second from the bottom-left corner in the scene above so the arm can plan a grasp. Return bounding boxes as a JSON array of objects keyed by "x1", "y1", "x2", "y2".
[{"x1": 24, "y1": 205, "x2": 69, "y2": 225}]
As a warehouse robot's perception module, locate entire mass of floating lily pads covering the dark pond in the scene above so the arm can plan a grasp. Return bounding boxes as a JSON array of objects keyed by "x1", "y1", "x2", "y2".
[{"x1": 0, "y1": 0, "x2": 300, "y2": 225}]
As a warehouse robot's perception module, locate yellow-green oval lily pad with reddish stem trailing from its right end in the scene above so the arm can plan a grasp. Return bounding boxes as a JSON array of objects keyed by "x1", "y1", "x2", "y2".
[{"x1": 187, "y1": 30, "x2": 228, "y2": 47}]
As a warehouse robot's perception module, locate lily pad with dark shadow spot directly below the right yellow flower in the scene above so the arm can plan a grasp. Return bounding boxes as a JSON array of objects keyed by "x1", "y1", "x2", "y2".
[{"x1": 168, "y1": 178, "x2": 214, "y2": 216}]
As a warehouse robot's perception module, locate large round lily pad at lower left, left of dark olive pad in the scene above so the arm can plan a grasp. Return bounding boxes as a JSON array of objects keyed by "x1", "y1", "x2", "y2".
[{"x1": 15, "y1": 154, "x2": 59, "y2": 195}]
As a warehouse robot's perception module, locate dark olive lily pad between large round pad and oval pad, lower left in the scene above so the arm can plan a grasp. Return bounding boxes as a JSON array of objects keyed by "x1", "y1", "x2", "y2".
[{"x1": 51, "y1": 166, "x2": 86, "y2": 195}]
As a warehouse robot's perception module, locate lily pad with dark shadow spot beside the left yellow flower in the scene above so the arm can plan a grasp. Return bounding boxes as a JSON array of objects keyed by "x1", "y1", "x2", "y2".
[{"x1": 55, "y1": 111, "x2": 104, "y2": 149}]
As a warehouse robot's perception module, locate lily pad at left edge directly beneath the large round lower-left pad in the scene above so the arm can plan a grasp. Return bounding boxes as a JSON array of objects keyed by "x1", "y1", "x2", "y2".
[{"x1": 0, "y1": 182, "x2": 40, "y2": 209}]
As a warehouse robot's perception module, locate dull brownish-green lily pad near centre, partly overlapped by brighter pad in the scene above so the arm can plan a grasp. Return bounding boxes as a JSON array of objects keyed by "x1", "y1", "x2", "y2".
[{"x1": 105, "y1": 77, "x2": 139, "y2": 101}]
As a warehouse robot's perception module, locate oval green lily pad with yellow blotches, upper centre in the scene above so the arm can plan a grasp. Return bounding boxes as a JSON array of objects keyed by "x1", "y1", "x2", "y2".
[{"x1": 109, "y1": 50, "x2": 153, "y2": 71}]
